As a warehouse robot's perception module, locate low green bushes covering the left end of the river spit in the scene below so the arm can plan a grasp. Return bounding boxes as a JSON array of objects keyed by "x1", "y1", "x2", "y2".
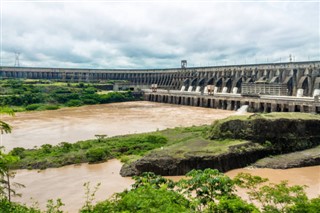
[{"x1": 10, "y1": 134, "x2": 167, "y2": 169}]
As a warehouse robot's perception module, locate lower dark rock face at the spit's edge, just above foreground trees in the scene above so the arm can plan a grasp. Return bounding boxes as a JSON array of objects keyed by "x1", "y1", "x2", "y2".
[{"x1": 120, "y1": 146, "x2": 269, "y2": 176}]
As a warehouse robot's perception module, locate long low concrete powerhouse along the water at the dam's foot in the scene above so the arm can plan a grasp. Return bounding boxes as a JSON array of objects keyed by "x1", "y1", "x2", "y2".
[{"x1": 144, "y1": 92, "x2": 320, "y2": 113}]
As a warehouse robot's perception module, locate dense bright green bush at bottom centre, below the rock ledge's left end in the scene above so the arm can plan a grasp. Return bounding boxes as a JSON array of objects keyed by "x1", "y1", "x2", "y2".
[{"x1": 90, "y1": 172, "x2": 193, "y2": 213}]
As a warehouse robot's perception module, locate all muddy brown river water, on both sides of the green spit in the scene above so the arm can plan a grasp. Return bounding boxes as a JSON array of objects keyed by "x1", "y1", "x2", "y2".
[{"x1": 2, "y1": 102, "x2": 320, "y2": 212}]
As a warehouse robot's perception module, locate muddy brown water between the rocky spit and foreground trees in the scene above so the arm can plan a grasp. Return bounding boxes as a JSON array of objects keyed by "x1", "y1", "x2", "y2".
[{"x1": 15, "y1": 159, "x2": 320, "y2": 212}]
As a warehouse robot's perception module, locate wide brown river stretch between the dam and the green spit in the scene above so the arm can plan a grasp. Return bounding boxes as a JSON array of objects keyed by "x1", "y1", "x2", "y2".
[{"x1": 1, "y1": 101, "x2": 235, "y2": 151}]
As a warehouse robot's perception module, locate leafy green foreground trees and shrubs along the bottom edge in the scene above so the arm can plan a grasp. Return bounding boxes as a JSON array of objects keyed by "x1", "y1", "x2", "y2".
[{"x1": 0, "y1": 165, "x2": 320, "y2": 213}]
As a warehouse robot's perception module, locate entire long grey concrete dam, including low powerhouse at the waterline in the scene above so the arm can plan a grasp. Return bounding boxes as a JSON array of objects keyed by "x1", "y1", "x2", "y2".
[{"x1": 0, "y1": 61, "x2": 320, "y2": 113}]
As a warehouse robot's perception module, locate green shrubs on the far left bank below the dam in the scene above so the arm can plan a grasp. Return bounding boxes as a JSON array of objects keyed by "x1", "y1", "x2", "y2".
[{"x1": 0, "y1": 79, "x2": 139, "y2": 111}]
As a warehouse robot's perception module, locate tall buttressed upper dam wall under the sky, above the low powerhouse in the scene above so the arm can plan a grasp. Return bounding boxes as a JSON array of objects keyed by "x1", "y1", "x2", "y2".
[{"x1": 0, "y1": 61, "x2": 320, "y2": 97}]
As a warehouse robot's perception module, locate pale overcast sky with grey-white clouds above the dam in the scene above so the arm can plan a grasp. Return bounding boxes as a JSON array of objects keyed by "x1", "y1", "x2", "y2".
[{"x1": 1, "y1": 0, "x2": 320, "y2": 68}]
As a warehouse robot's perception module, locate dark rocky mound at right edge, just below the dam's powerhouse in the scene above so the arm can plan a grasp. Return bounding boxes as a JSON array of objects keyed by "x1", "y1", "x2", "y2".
[{"x1": 209, "y1": 117, "x2": 320, "y2": 153}]
